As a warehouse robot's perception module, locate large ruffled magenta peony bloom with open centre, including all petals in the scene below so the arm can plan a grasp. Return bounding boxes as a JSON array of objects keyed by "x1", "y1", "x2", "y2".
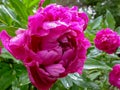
[{"x1": 0, "y1": 4, "x2": 90, "y2": 90}]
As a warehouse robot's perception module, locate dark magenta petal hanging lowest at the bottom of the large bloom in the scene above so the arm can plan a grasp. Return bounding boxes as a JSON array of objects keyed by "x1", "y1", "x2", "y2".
[{"x1": 27, "y1": 64, "x2": 56, "y2": 90}]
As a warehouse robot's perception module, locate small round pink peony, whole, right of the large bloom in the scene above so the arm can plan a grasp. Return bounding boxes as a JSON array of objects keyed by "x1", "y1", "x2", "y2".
[{"x1": 94, "y1": 28, "x2": 120, "y2": 54}]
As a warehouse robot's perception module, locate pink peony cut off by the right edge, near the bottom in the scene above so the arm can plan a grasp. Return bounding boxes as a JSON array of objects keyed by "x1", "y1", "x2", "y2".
[{"x1": 109, "y1": 64, "x2": 120, "y2": 88}]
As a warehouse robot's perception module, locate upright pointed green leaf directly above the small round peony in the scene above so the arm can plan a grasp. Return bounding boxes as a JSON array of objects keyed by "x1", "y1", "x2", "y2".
[{"x1": 105, "y1": 10, "x2": 115, "y2": 29}]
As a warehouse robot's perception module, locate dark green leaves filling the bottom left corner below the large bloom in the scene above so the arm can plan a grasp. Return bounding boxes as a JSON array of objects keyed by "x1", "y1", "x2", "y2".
[{"x1": 0, "y1": 49, "x2": 30, "y2": 90}]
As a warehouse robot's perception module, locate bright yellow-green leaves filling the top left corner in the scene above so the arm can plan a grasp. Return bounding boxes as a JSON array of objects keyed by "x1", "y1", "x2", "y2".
[{"x1": 0, "y1": 0, "x2": 39, "y2": 35}]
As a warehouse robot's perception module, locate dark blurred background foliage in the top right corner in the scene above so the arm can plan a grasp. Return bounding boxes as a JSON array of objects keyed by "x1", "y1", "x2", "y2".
[{"x1": 80, "y1": 0, "x2": 120, "y2": 26}]
